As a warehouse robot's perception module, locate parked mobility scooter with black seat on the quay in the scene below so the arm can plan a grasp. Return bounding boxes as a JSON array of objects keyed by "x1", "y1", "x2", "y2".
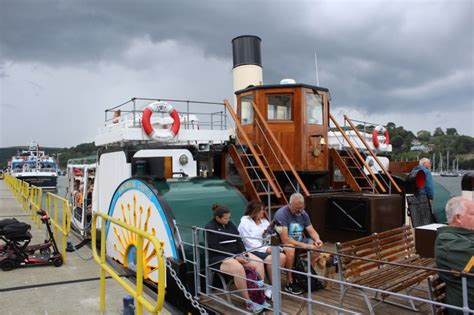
[{"x1": 0, "y1": 210, "x2": 63, "y2": 271}]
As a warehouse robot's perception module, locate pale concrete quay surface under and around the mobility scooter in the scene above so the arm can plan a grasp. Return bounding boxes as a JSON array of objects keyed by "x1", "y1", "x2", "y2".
[{"x1": 0, "y1": 180, "x2": 162, "y2": 315}]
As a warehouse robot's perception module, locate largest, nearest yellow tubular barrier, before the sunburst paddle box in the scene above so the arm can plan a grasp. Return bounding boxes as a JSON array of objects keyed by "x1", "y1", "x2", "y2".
[{"x1": 92, "y1": 212, "x2": 166, "y2": 315}]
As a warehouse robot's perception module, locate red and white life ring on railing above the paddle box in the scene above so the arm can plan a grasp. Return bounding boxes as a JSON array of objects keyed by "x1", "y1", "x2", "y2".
[{"x1": 142, "y1": 102, "x2": 181, "y2": 142}]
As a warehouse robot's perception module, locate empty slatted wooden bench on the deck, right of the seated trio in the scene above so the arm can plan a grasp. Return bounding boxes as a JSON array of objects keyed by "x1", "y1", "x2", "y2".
[{"x1": 336, "y1": 226, "x2": 434, "y2": 314}]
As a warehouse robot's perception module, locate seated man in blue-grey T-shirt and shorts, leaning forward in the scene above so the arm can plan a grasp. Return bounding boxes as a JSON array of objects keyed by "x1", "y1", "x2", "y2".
[{"x1": 274, "y1": 193, "x2": 323, "y2": 295}]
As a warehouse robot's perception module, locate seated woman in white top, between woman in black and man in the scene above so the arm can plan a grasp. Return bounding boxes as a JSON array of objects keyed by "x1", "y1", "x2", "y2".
[{"x1": 239, "y1": 200, "x2": 286, "y2": 298}]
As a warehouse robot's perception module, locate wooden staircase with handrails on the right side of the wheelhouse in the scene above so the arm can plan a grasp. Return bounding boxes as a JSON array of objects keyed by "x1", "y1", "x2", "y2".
[{"x1": 329, "y1": 114, "x2": 401, "y2": 194}]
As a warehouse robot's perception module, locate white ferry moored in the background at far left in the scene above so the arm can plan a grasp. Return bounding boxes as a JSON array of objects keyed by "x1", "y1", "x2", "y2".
[{"x1": 9, "y1": 143, "x2": 58, "y2": 189}]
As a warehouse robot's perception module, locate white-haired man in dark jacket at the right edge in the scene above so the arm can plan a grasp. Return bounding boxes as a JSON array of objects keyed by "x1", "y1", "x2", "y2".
[{"x1": 435, "y1": 197, "x2": 474, "y2": 314}]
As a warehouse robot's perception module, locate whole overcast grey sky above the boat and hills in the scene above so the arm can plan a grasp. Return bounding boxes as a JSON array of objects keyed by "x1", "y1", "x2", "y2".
[{"x1": 0, "y1": 0, "x2": 474, "y2": 147}]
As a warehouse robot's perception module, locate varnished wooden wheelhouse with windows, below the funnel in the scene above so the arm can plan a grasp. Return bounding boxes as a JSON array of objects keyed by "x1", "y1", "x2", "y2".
[{"x1": 236, "y1": 83, "x2": 330, "y2": 190}]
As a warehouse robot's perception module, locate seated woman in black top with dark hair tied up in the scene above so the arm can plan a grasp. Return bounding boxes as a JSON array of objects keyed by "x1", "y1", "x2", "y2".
[{"x1": 205, "y1": 204, "x2": 268, "y2": 313}]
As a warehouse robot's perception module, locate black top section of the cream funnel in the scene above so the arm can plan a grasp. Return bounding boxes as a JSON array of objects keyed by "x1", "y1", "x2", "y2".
[{"x1": 232, "y1": 35, "x2": 262, "y2": 68}]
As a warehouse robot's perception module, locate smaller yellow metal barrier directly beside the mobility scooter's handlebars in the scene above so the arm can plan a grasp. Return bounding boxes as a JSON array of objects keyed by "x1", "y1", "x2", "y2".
[{"x1": 44, "y1": 192, "x2": 71, "y2": 262}]
